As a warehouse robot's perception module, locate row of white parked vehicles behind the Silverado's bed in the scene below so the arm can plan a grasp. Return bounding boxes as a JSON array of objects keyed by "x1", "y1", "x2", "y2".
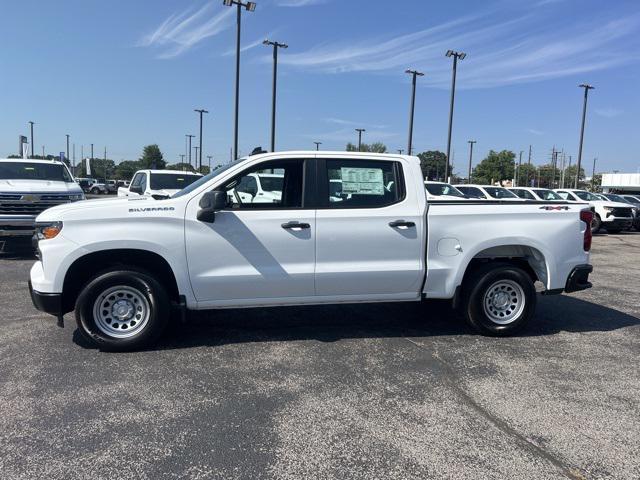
[{"x1": 424, "y1": 181, "x2": 640, "y2": 233}]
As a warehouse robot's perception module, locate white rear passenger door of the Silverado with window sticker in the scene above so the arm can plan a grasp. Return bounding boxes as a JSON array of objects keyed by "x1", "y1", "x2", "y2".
[{"x1": 315, "y1": 157, "x2": 425, "y2": 301}]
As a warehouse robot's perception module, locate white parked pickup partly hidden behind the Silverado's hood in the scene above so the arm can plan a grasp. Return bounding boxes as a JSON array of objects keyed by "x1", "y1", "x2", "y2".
[{"x1": 118, "y1": 170, "x2": 202, "y2": 197}]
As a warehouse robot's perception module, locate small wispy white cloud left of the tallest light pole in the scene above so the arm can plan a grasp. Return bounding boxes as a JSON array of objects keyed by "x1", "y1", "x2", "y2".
[{"x1": 138, "y1": 2, "x2": 233, "y2": 58}]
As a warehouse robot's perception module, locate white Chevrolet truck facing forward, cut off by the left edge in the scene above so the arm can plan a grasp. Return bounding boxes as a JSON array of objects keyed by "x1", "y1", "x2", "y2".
[{"x1": 0, "y1": 159, "x2": 84, "y2": 242}]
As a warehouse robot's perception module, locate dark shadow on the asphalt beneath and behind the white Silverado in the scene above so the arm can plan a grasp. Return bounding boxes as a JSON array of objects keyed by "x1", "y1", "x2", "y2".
[{"x1": 74, "y1": 295, "x2": 640, "y2": 350}]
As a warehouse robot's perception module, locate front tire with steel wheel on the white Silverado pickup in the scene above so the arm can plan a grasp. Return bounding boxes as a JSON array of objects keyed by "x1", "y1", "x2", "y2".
[{"x1": 75, "y1": 269, "x2": 171, "y2": 351}]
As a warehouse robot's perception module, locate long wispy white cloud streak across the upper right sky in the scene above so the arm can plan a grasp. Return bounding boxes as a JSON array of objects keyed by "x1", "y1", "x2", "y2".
[{"x1": 281, "y1": 13, "x2": 640, "y2": 88}]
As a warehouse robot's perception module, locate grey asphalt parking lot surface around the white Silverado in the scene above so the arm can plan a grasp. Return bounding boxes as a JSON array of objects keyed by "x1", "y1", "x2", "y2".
[{"x1": 0, "y1": 234, "x2": 640, "y2": 479}]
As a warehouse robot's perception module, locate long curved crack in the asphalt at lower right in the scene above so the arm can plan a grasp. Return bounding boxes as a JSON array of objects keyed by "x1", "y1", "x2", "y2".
[{"x1": 404, "y1": 337, "x2": 586, "y2": 480}]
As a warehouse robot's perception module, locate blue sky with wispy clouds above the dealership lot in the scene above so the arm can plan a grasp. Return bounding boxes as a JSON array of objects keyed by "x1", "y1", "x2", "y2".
[{"x1": 0, "y1": 0, "x2": 640, "y2": 172}]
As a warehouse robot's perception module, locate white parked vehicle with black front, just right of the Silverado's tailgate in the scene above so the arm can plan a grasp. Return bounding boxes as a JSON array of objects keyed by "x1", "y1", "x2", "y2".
[{"x1": 554, "y1": 188, "x2": 633, "y2": 233}]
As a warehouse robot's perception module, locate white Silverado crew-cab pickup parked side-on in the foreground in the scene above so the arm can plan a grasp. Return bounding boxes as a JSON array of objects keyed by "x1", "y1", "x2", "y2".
[{"x1": 30, "y1": 151, "x2": 592, "y2": 350}]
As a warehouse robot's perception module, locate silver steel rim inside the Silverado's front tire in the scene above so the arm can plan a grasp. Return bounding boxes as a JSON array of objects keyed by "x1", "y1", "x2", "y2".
[{"x1": 93, "y1": 285, "x2": 151, "y2": 338}]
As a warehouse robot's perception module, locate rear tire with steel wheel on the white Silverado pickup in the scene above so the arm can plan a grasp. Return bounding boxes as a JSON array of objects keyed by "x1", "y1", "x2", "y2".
[{"x1": 462, "y1": 263, "x2": 537, "y2": 337}]
